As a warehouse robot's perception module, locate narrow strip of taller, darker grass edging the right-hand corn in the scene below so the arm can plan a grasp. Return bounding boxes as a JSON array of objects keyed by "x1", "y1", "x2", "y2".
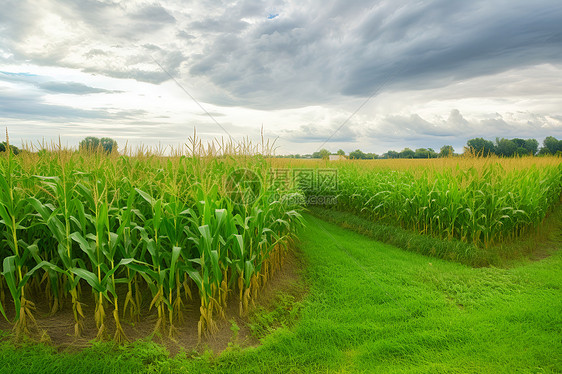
[{"x1": 309, "y1": 207, "x2": 486, "y2": 266}]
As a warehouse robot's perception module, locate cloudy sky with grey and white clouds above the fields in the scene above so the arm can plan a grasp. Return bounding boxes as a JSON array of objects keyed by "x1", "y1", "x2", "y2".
[{"x1": 0, "y1": 0, "x2": 562, "y2": 154}]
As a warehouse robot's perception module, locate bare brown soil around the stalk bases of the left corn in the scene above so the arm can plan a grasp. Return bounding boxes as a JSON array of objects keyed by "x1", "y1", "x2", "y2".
[{"x1": 0, "y1": 251, "x2": 303, "y2": 355}]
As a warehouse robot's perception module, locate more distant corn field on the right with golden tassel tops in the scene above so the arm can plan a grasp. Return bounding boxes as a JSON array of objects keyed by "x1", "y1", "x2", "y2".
[{"x1": 294, "y1": 157, "x2": 562, "y2": 247}]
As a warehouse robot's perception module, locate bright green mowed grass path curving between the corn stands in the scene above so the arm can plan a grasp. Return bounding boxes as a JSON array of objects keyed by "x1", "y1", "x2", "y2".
[{"x1": 0, "y1": 216, "x2": 562, "y2": 373}]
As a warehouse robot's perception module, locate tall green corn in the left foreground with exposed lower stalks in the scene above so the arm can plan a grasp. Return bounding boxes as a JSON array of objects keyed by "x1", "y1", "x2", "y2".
[{"x1": 0, "y1": 142, "x2": 302, "y2": 342}]
